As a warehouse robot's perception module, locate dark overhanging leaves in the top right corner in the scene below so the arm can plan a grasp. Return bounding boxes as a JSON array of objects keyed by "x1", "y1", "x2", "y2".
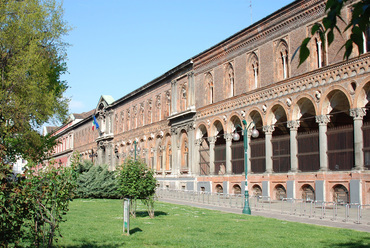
[{"x1": 293, "y1": 0, "x2": 370, "y2": 65}]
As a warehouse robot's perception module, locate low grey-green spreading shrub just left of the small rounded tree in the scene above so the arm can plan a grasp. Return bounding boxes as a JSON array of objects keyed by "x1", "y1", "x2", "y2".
[{"x1": 77, "y1": 160, "x2": 119, "y2": 198}]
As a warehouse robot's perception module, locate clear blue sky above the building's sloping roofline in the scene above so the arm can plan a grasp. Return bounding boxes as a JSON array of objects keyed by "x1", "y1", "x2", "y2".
[{"x1": 62, "y1": 0, "x2": 293, "y2": 113}]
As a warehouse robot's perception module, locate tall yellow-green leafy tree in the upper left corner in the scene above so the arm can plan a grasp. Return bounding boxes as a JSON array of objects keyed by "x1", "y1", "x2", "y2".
[{"x1": 0, "y1": 0, "x2": 69, "y2": 165}]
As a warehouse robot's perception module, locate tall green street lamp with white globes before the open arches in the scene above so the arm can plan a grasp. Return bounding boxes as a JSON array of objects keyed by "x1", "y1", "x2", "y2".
[{"x1": 233, "y1": 120, "x2": 259, "y2": 214}]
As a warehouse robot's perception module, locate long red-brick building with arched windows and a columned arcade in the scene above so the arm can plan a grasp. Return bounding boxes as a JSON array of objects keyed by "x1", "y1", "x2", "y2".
[{"x1": 49, "y1": 0, "x2": 370, "y2": 204}]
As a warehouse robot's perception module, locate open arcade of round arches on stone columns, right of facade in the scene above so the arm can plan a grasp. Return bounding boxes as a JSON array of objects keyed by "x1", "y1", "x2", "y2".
[{"x1": 196, "y1": 83, "x2": 370, "y2": 175}]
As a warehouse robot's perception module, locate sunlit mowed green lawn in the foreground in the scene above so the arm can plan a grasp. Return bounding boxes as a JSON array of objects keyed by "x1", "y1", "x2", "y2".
[{"x1": 55, "y1": 199, "x2": 370, "y2": 248}]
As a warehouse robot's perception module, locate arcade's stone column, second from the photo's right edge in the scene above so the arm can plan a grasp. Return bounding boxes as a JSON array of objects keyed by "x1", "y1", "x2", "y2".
[{"x1": 316, "y1": 115, "x2": 330, "y2": 171}]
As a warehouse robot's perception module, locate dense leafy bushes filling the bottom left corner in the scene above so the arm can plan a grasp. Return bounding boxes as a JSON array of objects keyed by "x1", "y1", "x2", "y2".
[{"x1": 0, "y1": 160, "x2": 77, "y2": 247}]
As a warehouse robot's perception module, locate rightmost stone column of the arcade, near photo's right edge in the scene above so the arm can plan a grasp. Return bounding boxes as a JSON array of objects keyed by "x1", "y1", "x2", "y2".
[{"x1": 349, "y1": 108, "x2": 366, "y2": 170}]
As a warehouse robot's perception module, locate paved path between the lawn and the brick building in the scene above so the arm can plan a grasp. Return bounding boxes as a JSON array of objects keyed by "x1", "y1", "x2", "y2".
[{"x1": 158, "y1": 198, "x2": 370, "y2": 233}]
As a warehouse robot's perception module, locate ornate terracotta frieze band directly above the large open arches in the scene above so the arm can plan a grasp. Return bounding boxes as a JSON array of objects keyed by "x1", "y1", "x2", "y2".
[{"x1": 196, "y1": 53, "x2": 370, "y2": 120}]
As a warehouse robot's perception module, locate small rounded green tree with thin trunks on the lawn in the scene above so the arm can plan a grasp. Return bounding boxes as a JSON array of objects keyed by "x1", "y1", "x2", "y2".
[{"x1": 117, "y1": 158, "x2": 156, "y2": 218}]
